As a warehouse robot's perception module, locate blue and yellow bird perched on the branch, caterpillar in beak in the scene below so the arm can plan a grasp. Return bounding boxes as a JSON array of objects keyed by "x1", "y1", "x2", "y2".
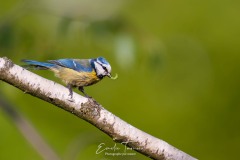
[{"x1": 22, "y1": 57, "x2": 118, "y2": 99}]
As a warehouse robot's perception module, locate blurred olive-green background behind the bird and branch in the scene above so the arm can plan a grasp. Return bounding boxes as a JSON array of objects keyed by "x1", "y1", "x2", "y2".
[{"x1": 0, "y1": 0, "x2": 240, "y2": 160}]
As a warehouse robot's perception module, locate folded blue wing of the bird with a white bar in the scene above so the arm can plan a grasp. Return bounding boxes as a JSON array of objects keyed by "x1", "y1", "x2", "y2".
[{"x1": 48, "y1": 59, "x2": 93, "y2": 72}]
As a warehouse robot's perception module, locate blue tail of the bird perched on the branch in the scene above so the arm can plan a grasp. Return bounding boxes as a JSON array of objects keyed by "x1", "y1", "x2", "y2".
[{"x1": 22, "y1": 59, "x2": 56, "y2": 69}]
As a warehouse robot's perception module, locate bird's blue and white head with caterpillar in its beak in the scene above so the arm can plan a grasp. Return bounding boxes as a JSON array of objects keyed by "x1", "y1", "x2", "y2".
[{"x1": 93, "y1": 57, "x2": 117, "y2": 79}]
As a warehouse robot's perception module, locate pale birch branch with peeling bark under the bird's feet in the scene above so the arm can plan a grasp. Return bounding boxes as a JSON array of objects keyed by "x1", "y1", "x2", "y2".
[{"x1": 0, "y1": 57, "x2": 198, "y2": 160}]
